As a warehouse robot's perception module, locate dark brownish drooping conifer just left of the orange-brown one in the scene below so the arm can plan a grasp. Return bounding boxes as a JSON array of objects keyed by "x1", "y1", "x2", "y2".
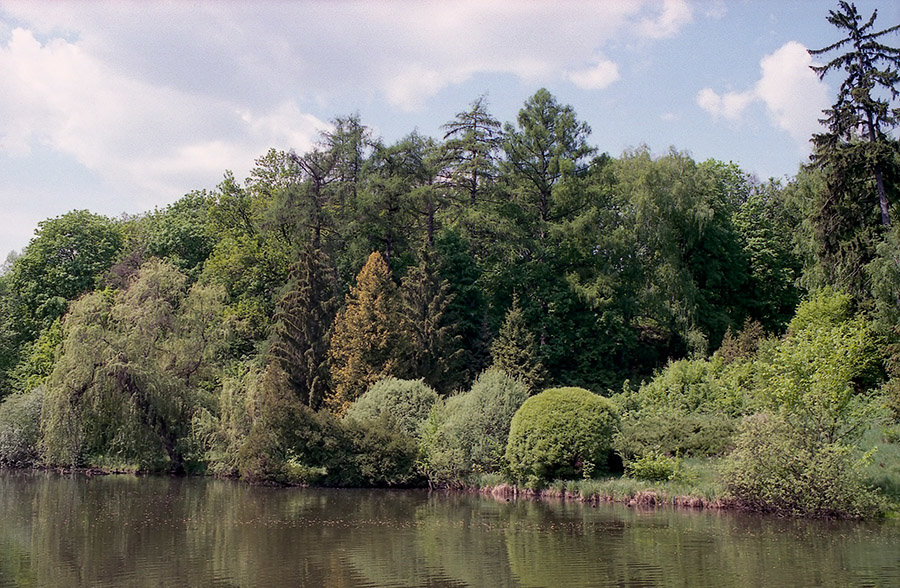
[{"x1": 269, "y1": 244, "x2": 337, "y2": 410}]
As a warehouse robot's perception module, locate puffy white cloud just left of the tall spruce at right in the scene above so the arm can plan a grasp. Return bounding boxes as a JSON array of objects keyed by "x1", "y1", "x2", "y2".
[{"x1": 696, "y1": 41, "x2": 828, "y2": 147}]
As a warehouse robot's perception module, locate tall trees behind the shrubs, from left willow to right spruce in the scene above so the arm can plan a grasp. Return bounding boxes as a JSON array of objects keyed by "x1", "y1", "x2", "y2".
[{"x1": 0, "y1": 2, "x2": 900, "y2": 520}]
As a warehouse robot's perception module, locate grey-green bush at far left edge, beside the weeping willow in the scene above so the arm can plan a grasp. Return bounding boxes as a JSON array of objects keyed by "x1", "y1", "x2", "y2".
[{"x1": 0, "y1": 387, "x2": 44, "y2": 467}]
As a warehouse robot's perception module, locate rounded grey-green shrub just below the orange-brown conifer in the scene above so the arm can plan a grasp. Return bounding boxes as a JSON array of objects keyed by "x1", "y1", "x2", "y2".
[{"x1": 345, "y1": 378, "x2": 438, "y2": 437}]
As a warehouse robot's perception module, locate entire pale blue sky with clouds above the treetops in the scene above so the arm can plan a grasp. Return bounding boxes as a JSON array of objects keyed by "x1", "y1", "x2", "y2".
[{"x1": 0, "y1": 0, "x2": 900, "y2": 260}]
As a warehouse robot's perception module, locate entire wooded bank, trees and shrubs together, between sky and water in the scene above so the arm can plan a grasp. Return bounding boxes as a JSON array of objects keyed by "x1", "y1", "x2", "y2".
[{"x1": 0, "y1": 3, "x2": 900, "y2": 517}]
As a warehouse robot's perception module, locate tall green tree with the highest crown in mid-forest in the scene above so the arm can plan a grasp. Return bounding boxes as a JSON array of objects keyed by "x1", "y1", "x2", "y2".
[{"x1": 484, "y1": 89, "x2": 602, "y2": 385}]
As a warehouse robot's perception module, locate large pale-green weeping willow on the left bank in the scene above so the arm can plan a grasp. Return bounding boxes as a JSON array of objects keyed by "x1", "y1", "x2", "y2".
[{"x1": 41, "y1": 261, "x2": 222, "y2": 472}]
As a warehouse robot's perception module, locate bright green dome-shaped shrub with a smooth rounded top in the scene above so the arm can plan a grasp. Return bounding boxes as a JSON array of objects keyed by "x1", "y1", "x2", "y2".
[{"x1": 506, "y1": 388, "x2": 619, "y2": 488}]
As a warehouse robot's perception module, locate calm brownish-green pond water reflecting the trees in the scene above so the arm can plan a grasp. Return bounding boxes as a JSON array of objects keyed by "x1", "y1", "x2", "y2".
[{"x1": 0, "y1": 471, "x2": 900, "y2": 588}]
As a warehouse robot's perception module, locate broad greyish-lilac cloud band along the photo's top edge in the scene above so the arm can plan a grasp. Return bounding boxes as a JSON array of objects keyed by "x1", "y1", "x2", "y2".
[{"x1": 0, "y1": 0, "x2": 692, "y2": 115}]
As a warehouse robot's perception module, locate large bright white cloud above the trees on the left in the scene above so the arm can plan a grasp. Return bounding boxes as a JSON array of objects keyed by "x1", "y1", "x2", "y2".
[{"x1": 0, "y1": 28, "x2": 326, "y2": 206}]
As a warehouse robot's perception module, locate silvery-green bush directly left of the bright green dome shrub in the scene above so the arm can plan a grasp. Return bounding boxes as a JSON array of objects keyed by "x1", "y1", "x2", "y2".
[{"x1": 422, "y1": 369, "x2": 528, "y2": 484}]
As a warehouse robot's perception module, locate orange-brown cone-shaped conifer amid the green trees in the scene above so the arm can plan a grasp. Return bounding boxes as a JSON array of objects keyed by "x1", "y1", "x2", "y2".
[{"x1": 326, "y1": 252, "x2": 409, "y2": 415}]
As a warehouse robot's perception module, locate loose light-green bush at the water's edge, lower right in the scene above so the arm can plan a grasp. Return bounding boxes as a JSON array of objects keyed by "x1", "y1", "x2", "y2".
[{"x1": 724, "y1": 414, "x2": 883, "y2": 518}]
